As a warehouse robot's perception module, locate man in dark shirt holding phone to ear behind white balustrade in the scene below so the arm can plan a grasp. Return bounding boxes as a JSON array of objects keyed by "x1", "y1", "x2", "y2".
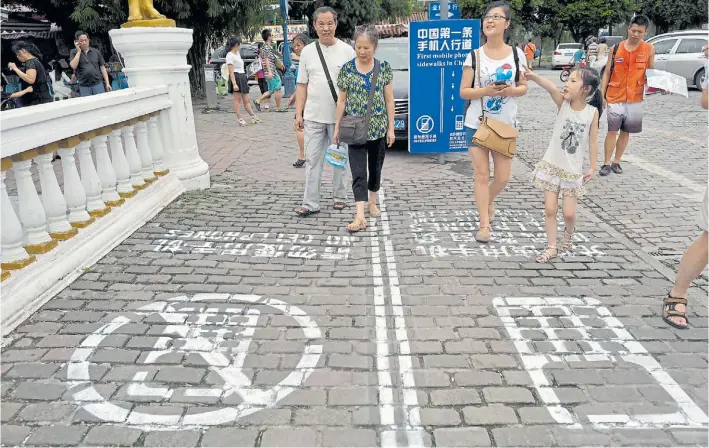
[{"x1": 69, "y1": 31, "x2": 111, "y2": 96}]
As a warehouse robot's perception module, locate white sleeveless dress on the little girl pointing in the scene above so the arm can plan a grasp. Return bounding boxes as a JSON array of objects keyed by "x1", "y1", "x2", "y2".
[{"x1": 533, "y1": 101, "x2": 596, "y2": 197}]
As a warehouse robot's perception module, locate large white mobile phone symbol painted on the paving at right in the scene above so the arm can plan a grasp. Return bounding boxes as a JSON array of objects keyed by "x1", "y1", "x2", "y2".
[{"x1": 493, "y1": 297, "x2": 709, "y2": 431}]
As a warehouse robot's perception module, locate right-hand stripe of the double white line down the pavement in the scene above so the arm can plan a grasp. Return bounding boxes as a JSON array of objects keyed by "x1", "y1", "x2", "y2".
[{"x1": 379, "y1": 189, "x2": 424, "y2": 447}]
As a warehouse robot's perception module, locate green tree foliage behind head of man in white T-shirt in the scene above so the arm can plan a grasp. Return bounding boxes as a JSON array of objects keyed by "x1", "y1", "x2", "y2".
[{"x1": 289, "y1": 0, "x2": 383, "y2": 38}]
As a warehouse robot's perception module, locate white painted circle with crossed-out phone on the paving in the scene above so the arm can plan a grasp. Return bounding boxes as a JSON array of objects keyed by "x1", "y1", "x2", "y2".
[{"x1": 67, "y1": 294, "x2": 322, "y2": 430}]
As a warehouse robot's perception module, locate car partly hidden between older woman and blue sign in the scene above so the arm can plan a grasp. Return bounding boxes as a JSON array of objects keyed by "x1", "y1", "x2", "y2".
[{"x1": 374, "y1": 37, "x2": 409, "y2": 140}]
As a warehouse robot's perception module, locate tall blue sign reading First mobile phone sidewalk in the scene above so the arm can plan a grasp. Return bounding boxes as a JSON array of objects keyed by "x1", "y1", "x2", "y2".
[{"x1": 409, "y1": 20, "x2": 480, "y2": 154}]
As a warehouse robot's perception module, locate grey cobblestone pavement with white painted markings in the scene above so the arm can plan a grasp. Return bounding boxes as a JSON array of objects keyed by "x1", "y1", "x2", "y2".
[{"x1": 1, "y1": 72, "x2": 709, "y2": 447}]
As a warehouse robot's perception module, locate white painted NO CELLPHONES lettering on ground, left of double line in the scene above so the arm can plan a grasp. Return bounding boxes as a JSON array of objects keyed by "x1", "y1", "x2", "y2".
[{"x1": 153, "y1": 230, "x2": 361, "y2": 260}]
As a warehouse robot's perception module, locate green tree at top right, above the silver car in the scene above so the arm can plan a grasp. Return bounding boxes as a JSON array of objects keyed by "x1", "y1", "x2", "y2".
[{"x1": 641, "y1": 0, "x2": 709, "y2": 33}]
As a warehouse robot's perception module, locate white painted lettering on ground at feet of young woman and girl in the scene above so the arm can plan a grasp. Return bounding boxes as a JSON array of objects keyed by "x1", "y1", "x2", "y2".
[{"x1": 409, "y1": 209, "x2": 605, "y2": 258}]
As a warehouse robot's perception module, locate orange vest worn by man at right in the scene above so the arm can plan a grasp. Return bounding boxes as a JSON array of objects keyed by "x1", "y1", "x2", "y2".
[{"x1": 606, "y1": 41, "x2": 652, "y2": 104}]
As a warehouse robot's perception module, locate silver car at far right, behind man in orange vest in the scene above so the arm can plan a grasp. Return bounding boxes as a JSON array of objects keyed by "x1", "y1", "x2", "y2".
[{"x1": 647, "y1": 30, "x2": 709, "y2": 88}]
